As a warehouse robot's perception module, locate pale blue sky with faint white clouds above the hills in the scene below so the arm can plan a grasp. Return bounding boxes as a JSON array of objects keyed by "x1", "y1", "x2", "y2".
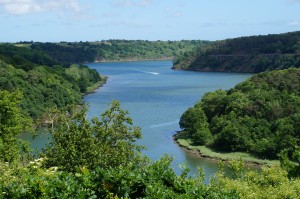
[{"x1": 0, "y1": 0, "x2": 300, "y2": 42}]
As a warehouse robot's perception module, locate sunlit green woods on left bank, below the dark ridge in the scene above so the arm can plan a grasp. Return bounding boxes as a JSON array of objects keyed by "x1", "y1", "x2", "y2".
[{"x1": 0, "y1": 60, "x2": 101, "y2": 119}]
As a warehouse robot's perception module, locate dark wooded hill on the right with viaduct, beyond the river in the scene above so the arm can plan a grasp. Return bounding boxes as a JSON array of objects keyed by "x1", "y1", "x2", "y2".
[{"x1": 173, "y1": 31, "x2": 300, "y2": 73}]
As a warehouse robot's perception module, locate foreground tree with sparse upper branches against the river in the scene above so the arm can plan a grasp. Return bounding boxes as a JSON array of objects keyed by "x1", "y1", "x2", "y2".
[{"x1": 44, "y1": 101, "x2": 141, "y2": 172}]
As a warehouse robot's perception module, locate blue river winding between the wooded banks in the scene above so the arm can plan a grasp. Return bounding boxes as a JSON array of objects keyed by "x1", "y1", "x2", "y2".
[{"x1": 84, "y1": 61, "x2": 251, "y2": 181}]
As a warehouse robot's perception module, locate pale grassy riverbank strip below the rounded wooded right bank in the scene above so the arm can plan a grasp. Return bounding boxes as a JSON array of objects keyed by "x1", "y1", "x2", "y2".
[{"x1": 173, "y1": 134, "x2": 280, "y2": 166}]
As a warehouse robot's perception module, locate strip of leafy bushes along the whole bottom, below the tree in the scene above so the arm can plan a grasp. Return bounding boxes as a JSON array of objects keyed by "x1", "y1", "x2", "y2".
[{"x1": 0, "y1": 157, "x2": 300, "y2": 199}]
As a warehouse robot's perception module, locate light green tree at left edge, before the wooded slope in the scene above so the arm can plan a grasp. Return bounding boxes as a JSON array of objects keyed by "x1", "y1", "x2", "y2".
[{"x1": 0, "y1": 90, "x2": 31, "y2": 163}]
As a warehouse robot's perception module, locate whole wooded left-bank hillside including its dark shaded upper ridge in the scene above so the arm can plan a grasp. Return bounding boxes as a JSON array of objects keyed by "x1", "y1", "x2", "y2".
[{"x1": 0, "y1": 44, "x2": 103, "y2": 122}]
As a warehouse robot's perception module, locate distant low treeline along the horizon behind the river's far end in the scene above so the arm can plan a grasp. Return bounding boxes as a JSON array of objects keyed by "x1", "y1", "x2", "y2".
[{"x1": 18, "y1": 40, "x2": 211, "y2": 64}]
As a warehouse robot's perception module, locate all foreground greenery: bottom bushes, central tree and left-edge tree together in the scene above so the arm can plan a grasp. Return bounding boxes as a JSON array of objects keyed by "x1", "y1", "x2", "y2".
[{"x1": 0, "y1": 91, "x2": 300, "y2": 199}]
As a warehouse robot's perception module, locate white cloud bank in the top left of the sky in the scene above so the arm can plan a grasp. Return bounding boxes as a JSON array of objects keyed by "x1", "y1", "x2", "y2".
[{"x1": 0, "y1": 0, "x2": 83, "y2": 15}]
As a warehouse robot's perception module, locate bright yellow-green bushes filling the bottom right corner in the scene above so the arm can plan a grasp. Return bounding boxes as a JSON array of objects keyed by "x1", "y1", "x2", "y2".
[{"x1": 210, "y1": 162, "x2": 300, "y2": 199}]
